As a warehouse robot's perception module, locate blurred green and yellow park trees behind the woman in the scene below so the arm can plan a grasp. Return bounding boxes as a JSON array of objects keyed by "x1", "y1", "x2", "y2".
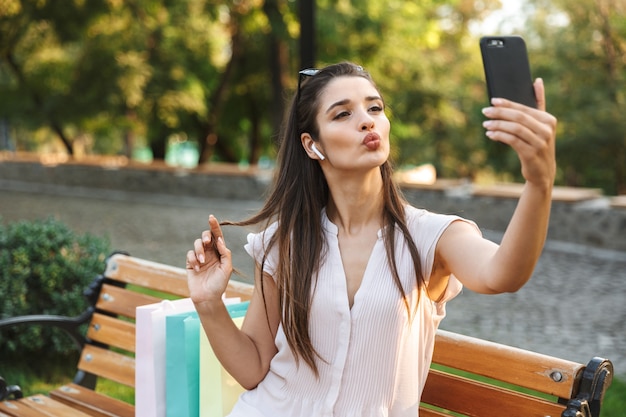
[{"x1": 0, "y1": 0, "x2": 626, "y2": 195}]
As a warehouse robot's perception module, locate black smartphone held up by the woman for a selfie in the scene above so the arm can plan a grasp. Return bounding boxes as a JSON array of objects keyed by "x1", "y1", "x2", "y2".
[{"x1": 480, "y1": 36, "x2": 537, "y2": 108}]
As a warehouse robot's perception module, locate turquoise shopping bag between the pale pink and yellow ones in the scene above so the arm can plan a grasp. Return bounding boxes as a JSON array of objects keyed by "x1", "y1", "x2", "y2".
[{"x1": 165, "y1": 311, "x2": 200, "y2": 417}]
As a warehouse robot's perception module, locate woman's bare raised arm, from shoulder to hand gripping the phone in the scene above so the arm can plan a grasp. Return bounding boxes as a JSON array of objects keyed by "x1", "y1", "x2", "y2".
[{"x1": 436, "y1": 80, "x2": 556, "y2": 294}]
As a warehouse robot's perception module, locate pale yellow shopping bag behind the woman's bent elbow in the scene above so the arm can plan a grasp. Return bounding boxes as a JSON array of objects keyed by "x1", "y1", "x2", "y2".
[{"x1": 199, "y1": 301, "x2": 249, "y2": 417}]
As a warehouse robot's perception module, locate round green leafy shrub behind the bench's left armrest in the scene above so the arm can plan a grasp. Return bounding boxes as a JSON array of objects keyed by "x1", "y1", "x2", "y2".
[{"x1": 0, "y1": 218, "x2": 110, "y2": 357}]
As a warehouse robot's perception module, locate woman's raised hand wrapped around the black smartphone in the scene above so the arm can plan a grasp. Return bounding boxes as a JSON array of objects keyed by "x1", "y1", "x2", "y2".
[{"x1": 483, "y1": 78, "x2": 557, "y2": 187}]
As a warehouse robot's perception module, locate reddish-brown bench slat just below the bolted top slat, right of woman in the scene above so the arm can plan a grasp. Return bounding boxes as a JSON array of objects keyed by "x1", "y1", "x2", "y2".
[{"x1": 422, "y1": 370, "x2": 565, "y2": 417}]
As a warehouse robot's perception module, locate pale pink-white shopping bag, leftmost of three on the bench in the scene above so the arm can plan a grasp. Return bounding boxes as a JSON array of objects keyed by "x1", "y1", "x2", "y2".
[{"x1": 135, "y1": 298, "x2": 194, "y2": 417}]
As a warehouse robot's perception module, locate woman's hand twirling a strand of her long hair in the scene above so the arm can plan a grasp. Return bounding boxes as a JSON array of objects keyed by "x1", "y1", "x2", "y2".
[{"x1": 186, "y1": 215, "x2": 233, "y2": 308}]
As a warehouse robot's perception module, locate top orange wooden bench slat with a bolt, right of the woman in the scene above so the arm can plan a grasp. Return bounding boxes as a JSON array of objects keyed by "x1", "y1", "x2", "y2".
[{"x1": 433, "y1": 330, "x2": 584, "y2": 398}]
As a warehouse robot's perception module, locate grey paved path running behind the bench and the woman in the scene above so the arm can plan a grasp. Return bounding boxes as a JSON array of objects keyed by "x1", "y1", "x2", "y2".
[{"x1": 0, "y1": 181, "x2": 626, "y2": 376}]
